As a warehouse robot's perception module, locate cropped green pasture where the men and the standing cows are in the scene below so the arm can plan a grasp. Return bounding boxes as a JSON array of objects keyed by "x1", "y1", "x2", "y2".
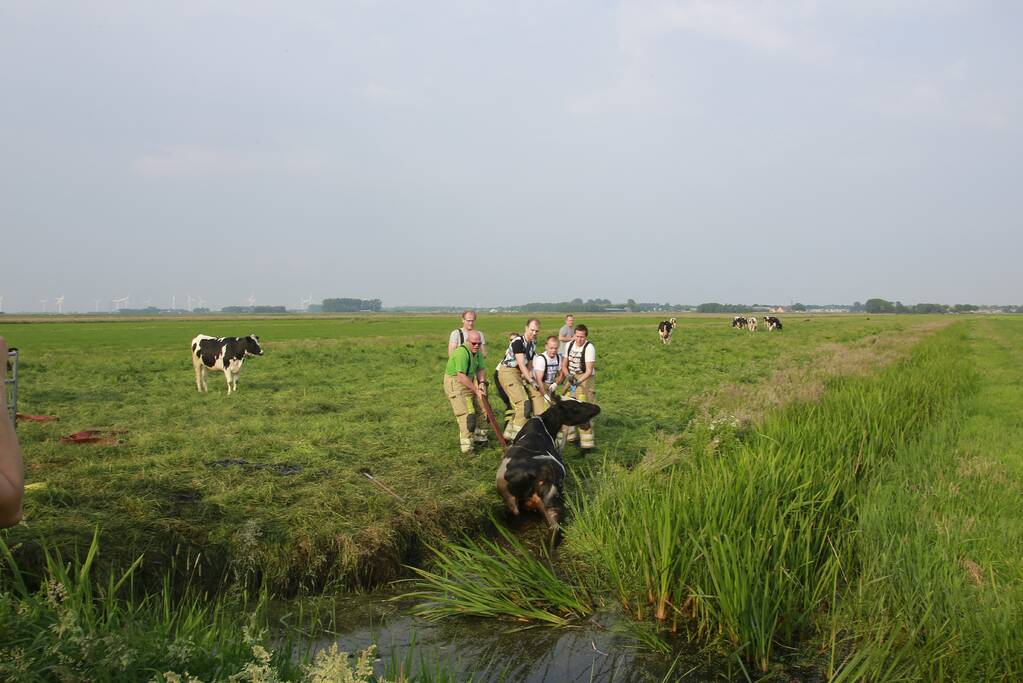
[{"x1": 0, "y1": 315, "x2": 918, "y2": 593}]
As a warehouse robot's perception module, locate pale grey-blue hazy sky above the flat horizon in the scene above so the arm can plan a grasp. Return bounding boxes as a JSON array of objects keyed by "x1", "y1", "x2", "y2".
[{"x1": 0, "y1": 0, "x2": 1023, "y2": 312}]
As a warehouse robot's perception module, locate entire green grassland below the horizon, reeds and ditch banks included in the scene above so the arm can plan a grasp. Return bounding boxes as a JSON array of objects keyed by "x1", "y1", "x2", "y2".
[{"x1": 0, "y1": 316, "x2": 1023, "y2": 681}]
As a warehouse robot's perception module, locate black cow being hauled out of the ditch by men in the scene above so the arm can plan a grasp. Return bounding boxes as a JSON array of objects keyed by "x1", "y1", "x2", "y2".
[{"x1": 497, "y1": 395, "x2": 601, "y2": 530}]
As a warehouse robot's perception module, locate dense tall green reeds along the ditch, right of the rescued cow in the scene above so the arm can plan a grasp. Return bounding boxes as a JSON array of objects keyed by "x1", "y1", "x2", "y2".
[{"x1": 566, "y1": 331, "x2": 972, "y2": 671}]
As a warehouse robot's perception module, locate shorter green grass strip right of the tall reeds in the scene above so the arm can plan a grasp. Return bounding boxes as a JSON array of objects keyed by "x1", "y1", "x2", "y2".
[{"x1": 833, "y1": 319, "x2": 1023, "y2": 681}]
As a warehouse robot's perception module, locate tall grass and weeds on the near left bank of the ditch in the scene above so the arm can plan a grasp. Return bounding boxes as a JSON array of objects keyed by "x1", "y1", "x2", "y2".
[{"x1": 0, "y1": 532, "x2": 454, "y2": 683}]
